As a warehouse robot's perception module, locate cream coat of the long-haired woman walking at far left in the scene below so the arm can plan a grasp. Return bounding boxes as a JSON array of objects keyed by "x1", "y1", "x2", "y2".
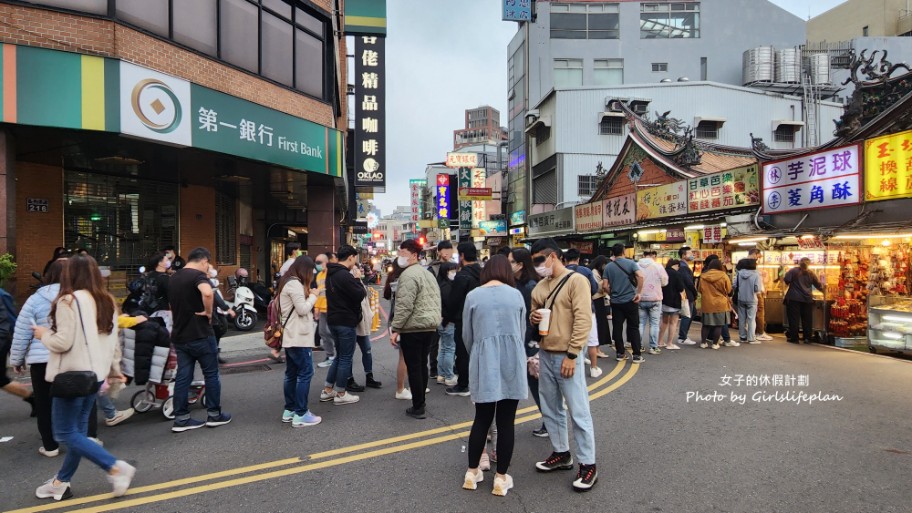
[{"x1": 41, "y1": 290, "x2": 121, "y2": 382}]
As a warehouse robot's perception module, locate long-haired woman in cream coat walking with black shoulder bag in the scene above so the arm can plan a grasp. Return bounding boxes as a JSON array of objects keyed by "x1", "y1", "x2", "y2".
[{"x1": 32, "y1": 255, "x2": 136, "y2": 501}]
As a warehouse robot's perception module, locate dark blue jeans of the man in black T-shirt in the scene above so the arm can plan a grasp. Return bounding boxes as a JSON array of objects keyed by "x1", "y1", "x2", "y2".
[{"x1": 174, "y1": 336, "x2": 222, "y2": 421}]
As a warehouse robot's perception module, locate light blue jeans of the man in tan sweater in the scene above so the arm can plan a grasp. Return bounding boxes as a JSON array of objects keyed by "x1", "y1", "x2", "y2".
[{"x1": 538, "y1": 351, "x2": 595, "y2": 465}]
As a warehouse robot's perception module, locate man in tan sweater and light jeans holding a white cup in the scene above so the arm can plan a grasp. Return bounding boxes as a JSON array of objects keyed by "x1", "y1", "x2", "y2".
[{"x1": 530, "y1": 239, "x2": 598, "y2": 492}]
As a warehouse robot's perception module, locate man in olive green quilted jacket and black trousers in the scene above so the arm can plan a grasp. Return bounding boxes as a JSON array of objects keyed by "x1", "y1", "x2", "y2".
[{"x1": 390, "y1": 239, "x2": 441, "y2": 419}]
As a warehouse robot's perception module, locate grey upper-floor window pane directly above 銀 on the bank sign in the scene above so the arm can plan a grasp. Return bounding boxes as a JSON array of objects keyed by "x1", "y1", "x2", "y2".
[{"x1": 219, "y1": 0, "x2": 259, "y2": 73}]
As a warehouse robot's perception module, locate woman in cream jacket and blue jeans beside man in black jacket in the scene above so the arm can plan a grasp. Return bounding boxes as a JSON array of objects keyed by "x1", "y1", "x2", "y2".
[{"x1": 276, "y1": 255, "x2": 323, "y2": 427}]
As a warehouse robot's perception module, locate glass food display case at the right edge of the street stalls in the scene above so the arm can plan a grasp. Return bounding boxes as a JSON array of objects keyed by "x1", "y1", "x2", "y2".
[{"x1": 868, "y1": 295, "x2": 912, "y2": 353}]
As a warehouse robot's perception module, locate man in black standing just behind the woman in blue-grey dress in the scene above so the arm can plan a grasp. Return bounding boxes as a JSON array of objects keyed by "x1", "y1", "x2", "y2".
[{"x1": 446, "y1": 242, "x2": 481, "y2": 397}]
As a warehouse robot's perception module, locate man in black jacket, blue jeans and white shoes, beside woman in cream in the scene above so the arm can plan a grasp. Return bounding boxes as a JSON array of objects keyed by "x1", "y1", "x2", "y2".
[{"x1": 320, "y1": 246, "x2": 367, "y2": 406}]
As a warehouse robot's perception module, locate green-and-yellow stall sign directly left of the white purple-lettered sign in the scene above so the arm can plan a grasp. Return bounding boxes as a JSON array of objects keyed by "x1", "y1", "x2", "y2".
[{"x1": 687, "y1": 164, "x2": 760, "y2": 214}]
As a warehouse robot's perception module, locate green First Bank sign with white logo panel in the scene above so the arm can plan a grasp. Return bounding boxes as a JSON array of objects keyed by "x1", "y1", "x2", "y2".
[{"x1": 120, "y1": 62, "x2": 341, "y2": 176}]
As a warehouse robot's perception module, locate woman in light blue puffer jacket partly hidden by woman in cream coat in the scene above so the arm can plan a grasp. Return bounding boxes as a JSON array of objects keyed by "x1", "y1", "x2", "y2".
[{"x1": 10, "y1": 258, "x2": 66, "y2": 457}]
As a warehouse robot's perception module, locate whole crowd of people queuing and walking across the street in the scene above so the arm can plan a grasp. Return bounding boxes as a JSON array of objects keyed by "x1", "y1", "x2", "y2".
[{"x1": 0, "y1": 239, "x2": 822, "y2": 500}]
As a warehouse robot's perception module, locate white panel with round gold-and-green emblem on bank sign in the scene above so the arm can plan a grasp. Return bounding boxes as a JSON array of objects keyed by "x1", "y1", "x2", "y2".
[{"x1": 120, "y1": 62, "x2": 192, "y2": 146}]
